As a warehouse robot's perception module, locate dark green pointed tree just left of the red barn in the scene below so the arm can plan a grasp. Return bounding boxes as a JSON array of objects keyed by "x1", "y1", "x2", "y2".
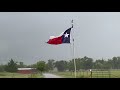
[{"x1": 5, "y1": 59, "x2": 17, "y2": 72}]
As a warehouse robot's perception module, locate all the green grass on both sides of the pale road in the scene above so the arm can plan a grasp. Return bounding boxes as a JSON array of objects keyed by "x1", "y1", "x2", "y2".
[{"x1": 0, "y1": 70, "x2": 120, "y2": 78}]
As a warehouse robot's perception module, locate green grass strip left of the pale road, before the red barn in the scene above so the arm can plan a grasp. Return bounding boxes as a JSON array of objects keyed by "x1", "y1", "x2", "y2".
[{"x1": 0, "y1": 72, "x2": 43, "y2": 78}]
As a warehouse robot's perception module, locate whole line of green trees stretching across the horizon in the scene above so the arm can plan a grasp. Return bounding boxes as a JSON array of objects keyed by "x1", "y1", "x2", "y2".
[{"x1": 0, "y1": 56, "x2": 120, "y2": 72}]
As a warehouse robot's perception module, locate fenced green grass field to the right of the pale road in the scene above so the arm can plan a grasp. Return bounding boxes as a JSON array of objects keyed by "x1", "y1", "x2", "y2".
[{"x1": 54, "y1": 70, "x2": 120, "y2": 78}]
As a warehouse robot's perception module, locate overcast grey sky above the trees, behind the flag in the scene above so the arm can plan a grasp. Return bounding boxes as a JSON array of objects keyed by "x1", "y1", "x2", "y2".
[{"x1": 0, "y1": 12, "x2": 120, "y2": 64}]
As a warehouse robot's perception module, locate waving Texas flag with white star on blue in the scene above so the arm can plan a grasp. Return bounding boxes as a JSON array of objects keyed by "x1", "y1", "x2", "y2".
[{"x1": 47, "y1": 28, "x2": 71, "y2": 45}]
